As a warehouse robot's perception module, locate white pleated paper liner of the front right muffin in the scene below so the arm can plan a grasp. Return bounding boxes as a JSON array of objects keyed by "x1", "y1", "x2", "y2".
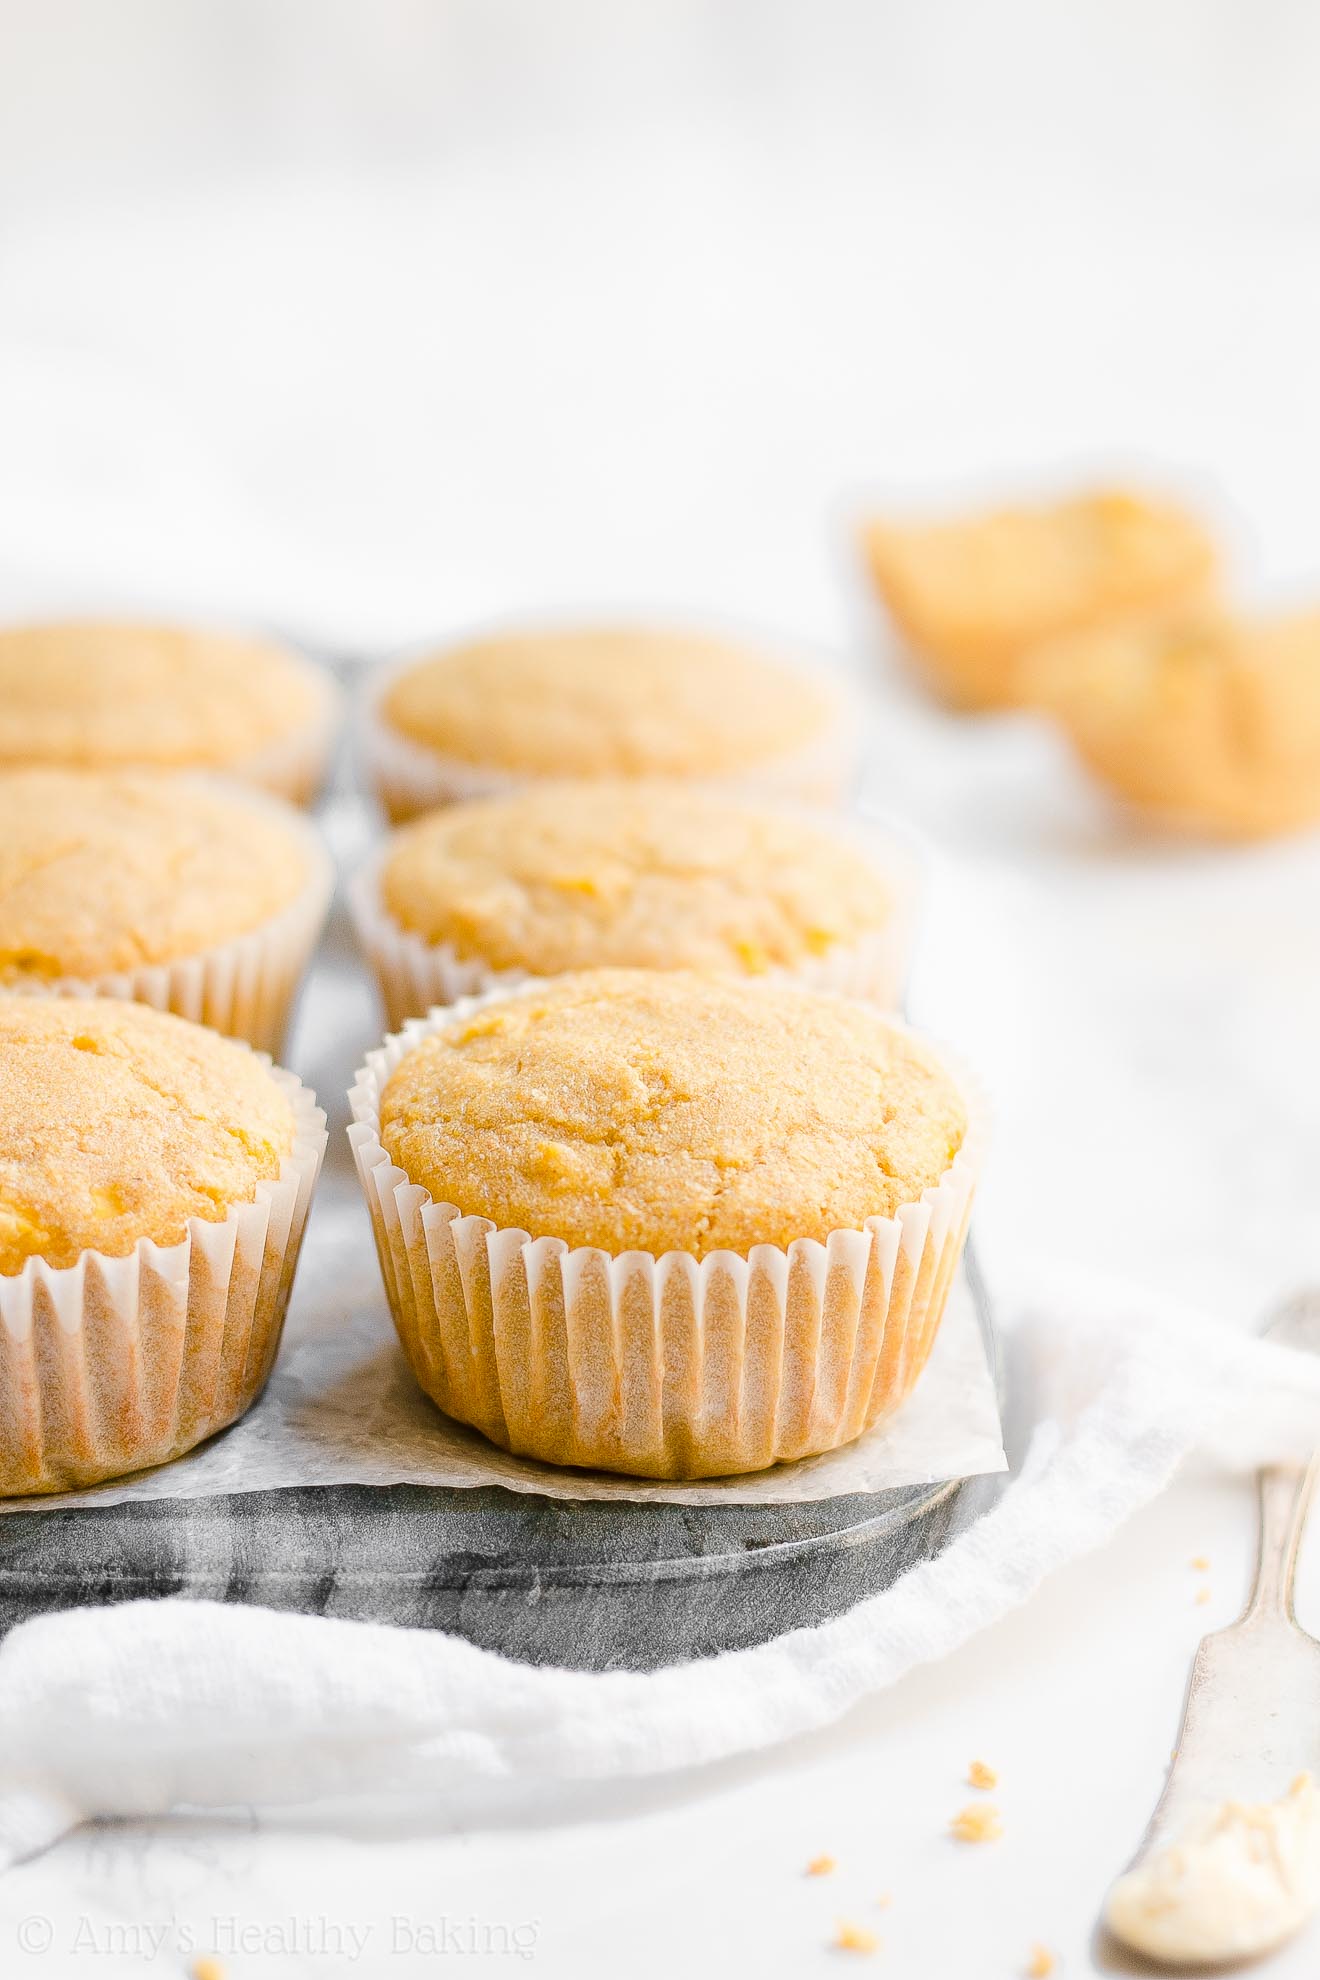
[{"x1": 348, "y1": 984, "x2": 988, "y2": 1477}]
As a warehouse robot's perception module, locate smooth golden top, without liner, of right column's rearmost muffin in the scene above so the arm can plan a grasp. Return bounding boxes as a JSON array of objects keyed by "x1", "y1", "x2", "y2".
[{"x1": 382, "y1": 626, "x2": 837, "y2": 776}]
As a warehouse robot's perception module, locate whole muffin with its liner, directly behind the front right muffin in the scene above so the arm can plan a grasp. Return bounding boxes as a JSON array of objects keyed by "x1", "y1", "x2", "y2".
[{"x1": 350, "y1": 780, "x2": 916, "y2": 1028}]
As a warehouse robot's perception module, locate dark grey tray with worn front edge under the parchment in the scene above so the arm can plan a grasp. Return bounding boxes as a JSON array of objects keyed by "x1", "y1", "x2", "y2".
[{"x1": 0, "y1": 1261, "x2": 1001, "y2": 1669}]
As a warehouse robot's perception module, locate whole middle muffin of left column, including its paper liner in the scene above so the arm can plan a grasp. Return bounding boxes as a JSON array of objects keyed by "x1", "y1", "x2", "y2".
[{"x1": 0, "y1": 768, "x2": 334, "y2": 1049}]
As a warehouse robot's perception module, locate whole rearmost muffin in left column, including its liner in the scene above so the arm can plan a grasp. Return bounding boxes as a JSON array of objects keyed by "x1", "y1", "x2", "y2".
[{"x1": 0, "y1": 622, "x2": 336, "y2": 802}]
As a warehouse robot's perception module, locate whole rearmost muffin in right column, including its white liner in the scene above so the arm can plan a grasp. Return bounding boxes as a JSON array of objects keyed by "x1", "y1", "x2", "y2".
[{"x1": 366, "y1": 626, "x2": 857, "y2": 824}]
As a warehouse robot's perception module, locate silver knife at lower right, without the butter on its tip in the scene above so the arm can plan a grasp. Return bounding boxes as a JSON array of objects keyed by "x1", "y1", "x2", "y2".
[{"x1": 1108, "y1": 1291, "x2": 1320, "y2": 1964}]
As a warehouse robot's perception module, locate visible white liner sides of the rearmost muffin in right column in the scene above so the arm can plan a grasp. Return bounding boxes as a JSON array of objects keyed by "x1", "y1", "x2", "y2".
[{"x1": 358, "y1": 642, "x2": 861, "y2": 826}]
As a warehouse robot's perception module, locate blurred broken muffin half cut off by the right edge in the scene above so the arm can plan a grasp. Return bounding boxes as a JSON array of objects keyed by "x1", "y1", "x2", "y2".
[{"x1": 1031, "y1": 608, "x2": 1320, "y2": 838}]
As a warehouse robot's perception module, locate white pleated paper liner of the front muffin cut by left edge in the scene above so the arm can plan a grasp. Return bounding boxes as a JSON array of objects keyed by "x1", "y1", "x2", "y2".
[{"x1": 0, "y1": 1065, "x2": 327, "y2": 1499}]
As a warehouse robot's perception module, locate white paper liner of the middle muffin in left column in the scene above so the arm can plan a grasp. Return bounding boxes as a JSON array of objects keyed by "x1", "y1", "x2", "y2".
[{"x1": 0, "y1": 780, "x2": 334, "y2": 1053}]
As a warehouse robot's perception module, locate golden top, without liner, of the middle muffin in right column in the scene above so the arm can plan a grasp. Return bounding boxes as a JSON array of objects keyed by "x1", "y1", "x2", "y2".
[{"x1": 380, "y1": 780, "x2": 893, "y2": 976}]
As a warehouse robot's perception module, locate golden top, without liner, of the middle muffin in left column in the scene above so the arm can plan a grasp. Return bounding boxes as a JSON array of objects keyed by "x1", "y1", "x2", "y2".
[{"x1": 0, "y1": 768, "x2": 309, "y2": 984}]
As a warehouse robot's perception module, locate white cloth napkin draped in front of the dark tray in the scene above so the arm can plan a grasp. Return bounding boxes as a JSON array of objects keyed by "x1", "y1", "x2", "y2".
[{"x1": 0, "y1": 1289, "x2": 1320, "y2": 1865}]
